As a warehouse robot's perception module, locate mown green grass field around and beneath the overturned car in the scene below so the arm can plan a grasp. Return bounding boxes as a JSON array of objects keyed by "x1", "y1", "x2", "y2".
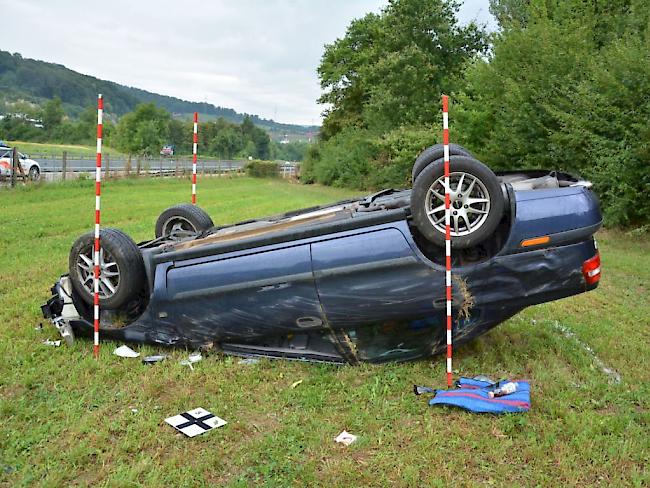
[{"x1": 0, "y1": 178, "x2": 650, "y2": 487}]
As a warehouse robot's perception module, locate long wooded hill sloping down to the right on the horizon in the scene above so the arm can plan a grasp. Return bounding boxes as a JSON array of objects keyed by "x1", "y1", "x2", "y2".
[{"x1": 0, "y1": 50, "x2": 319, "y2": 139}]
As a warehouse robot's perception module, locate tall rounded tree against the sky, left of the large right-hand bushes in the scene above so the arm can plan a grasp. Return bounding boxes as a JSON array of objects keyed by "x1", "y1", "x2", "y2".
[{"x1": 318, "y1": 0, "x2": 487, "y2": 139}]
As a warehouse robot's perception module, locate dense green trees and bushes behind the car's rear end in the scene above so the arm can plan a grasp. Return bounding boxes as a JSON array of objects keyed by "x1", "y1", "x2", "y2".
[{"x1": 303, "y1": 0, "x2": 650, "y2": 225}]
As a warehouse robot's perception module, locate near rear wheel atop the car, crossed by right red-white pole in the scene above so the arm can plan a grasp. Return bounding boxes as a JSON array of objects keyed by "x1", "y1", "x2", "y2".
[{"x1": 411, "y1": 156, "x2": 505, "y2": 249}]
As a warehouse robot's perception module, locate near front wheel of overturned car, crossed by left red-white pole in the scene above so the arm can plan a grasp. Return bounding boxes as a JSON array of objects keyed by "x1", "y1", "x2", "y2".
[{"x1": 68, "y1": 228, "x2": 145, "y2": 310}]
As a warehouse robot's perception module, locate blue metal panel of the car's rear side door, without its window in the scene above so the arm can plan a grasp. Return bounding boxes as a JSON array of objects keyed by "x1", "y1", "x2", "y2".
[{"x1": 312, "y1": 227, "x2": 444, "y2": 327}]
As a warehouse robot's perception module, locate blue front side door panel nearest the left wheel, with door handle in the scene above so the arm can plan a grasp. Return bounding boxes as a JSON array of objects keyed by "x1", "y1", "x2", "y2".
[{"x1": 162, "y1": 244, "x2": 323, "y2": 341}]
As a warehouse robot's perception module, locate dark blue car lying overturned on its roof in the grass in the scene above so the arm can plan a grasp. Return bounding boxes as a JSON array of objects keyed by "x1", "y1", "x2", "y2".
[{"x1": 42, "y1": 145, "x2": 602, "y2": 364}]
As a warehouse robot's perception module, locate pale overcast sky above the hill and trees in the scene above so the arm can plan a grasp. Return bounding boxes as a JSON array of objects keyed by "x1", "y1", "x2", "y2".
[{"x1": 0, "y1": 0, "x2": 494, "y2": 125}]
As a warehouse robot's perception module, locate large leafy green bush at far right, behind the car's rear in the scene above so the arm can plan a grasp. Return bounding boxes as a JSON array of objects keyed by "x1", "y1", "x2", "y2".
[{"x1": 452, "y1": 0, "x2": 650, "y2": 225}]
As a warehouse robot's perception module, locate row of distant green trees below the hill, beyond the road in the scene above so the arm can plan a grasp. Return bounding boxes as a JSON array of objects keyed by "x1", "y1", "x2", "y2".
[{"x1": 0, "y1": 97, "x2": 307, "y2": 161}]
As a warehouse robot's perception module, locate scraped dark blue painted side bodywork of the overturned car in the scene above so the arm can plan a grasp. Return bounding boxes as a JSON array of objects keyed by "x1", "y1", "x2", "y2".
[{"x1": 52, "y1": 187, "x2": 600, "y2": 363}]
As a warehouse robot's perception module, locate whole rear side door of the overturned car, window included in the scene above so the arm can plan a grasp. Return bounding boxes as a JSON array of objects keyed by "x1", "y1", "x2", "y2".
[{"x1": 312, "y1": 228, "x2": 445, "y2": 362}]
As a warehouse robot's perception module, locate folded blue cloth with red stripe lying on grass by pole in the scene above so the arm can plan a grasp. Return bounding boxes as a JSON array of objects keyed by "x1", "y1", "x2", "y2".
[{"x1": 429, "y1": 378, "x2": 530, "y2": 413}]
